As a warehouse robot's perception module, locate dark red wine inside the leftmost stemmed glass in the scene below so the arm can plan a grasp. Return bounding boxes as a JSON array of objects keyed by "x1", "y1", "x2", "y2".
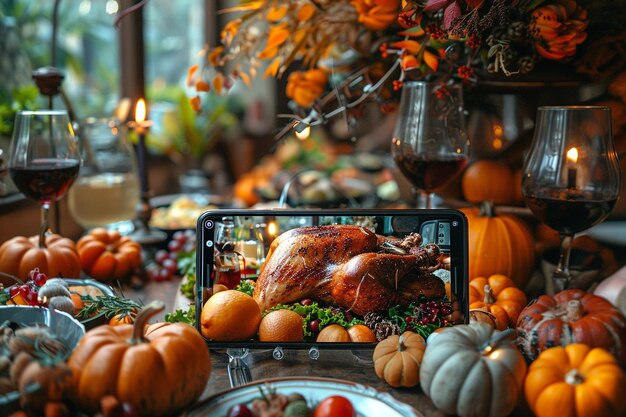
[{"x1": 9, "y1": 158, "x2": 80, "y2": 203}]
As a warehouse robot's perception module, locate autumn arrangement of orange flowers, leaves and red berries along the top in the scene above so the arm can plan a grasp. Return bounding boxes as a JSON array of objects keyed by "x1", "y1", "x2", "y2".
[{"x1": 188, "y1": 0, "x2": 625, "y2": 133}]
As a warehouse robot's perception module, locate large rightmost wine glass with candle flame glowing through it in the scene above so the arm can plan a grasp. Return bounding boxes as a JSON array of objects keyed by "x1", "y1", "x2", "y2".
[{"x1": 522, "y1": 106, "x2": 620, "y2": 294}]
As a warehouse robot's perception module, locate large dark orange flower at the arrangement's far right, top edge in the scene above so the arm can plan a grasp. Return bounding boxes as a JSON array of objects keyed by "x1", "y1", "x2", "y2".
[{"x1": 530, "y1": 0, "x2": 589, "y2": 60}]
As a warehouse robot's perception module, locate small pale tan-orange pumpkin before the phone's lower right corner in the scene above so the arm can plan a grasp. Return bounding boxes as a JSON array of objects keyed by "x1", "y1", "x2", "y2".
[{"x1": 373, "y1": 331, "x2": 426, "y2": 387}]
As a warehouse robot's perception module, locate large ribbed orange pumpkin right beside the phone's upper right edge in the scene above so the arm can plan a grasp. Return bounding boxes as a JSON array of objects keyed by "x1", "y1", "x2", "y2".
[{"x1": 462, "y1": 204, "x2": 535, "y2": 288}]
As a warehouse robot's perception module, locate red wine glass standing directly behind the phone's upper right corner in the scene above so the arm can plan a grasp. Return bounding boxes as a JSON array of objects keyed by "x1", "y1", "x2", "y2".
[{"x1": 391, "y1": 81, "x2": 469, "y2": 208}]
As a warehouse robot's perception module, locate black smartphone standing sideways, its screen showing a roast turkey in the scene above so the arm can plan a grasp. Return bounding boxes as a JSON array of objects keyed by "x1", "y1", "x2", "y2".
[{"x1": 196, "y1": 209, "x2": 468, "y2": 348}]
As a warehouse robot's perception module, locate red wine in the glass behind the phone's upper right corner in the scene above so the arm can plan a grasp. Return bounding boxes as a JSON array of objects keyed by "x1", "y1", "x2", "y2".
[{"x1": 394, "y1": 154, "x2": 467, "y2": 193}]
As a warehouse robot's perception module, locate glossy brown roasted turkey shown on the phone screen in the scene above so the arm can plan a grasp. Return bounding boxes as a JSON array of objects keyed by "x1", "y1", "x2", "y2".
[{"x1": 254, "y1": 225, "x2": 445, "y2": 316}]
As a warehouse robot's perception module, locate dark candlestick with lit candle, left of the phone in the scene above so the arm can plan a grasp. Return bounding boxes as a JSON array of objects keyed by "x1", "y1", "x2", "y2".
[{"x1": 128, "y1": 99, "x2": 167, "y2": 245}]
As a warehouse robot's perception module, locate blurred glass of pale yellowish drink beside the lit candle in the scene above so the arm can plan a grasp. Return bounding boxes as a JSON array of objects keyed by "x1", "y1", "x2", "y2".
[{"x1": 67, "y1": 118, "x2": 139, "y2": 231}]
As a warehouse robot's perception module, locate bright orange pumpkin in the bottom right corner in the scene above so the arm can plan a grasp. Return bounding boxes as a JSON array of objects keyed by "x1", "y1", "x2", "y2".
[{"x1": 524, "y1": 343, "x2": 626, "y2": 417}]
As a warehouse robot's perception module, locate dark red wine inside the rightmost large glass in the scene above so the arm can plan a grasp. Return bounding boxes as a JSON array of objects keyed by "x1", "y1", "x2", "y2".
[{"x1": 524, "y1": 189, "x2": 617, "y2": 235}]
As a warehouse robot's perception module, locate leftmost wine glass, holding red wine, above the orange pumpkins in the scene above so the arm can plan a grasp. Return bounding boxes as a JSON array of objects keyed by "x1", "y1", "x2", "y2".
[{"x1": 9, "y1": 110, "x2": 81, "y2": 247}]
